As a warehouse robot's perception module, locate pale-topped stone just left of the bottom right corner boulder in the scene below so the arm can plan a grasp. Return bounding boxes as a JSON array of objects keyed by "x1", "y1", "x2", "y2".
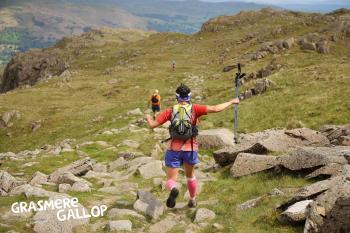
[{"x1": 278, "y1": 200, "x2": 313, "y2": 225}]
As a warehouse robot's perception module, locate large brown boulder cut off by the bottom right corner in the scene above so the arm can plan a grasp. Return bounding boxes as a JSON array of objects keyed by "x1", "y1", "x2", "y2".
[{"x1": 304, "y1": 179, "x2": 350, "y2": 233}]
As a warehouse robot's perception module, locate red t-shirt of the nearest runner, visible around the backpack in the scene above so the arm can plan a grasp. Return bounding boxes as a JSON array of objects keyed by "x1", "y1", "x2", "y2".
[{"x1": 157, "y1": 104, "x2": 207, "y2": 151}]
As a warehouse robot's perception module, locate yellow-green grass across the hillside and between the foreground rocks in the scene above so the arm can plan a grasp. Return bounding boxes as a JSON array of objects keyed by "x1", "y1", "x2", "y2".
[{"x1": 0, "y1": 9, "x2": 350, "y2": 232}]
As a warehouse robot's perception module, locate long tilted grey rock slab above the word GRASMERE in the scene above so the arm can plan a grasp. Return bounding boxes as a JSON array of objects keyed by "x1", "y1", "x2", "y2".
[{"x1": 49, "y1": 157, "x2": 92, "y2": 183}]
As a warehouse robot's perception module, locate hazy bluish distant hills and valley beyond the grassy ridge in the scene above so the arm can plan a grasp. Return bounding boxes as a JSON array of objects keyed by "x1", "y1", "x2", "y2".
[{"x1": 0, "y1": 0, "x2": 270, "y2": 64}]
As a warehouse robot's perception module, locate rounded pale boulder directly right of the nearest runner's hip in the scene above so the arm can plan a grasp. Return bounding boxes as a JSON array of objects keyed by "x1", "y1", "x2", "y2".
[{"x1": 197, "y1": 129, "x2": 235, "y2": 149}]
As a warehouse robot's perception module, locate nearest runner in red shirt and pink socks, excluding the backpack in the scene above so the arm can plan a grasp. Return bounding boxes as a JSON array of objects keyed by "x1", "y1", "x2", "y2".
[{"x1": 146, "y1": 84, "x2": 239, "y2": 208}]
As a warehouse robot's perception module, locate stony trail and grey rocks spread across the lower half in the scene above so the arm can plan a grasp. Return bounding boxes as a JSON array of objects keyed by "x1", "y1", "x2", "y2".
[{"x1": 0, "y1": 104, "x2": 350, "y2": 233}]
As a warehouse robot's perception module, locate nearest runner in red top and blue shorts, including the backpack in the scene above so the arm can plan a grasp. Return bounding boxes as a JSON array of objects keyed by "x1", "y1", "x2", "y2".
[{"x1": 145, "y1": 84, "x2": 239, "y2": 208}]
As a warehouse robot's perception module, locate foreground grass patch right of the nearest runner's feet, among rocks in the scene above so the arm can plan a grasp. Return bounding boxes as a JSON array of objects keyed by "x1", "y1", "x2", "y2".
[{"x1": 199, "y1": 172, "x2": 309, "y2": 233}]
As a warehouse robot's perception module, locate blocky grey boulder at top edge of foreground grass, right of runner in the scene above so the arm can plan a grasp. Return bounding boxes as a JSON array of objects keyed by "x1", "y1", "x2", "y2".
[{"x1": 231, "y1": 153, "x2": 278, "y2": 177}]
